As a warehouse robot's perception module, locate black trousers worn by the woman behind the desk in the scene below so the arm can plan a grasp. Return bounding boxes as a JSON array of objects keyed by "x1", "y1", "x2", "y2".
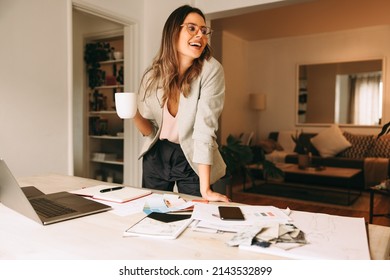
[{"x1": 142, "y1": 140, "x2": 201, "y2": 196}]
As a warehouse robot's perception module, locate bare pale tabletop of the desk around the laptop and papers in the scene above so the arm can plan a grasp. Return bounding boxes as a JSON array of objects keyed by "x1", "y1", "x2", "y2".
[{"x1": 0, "y1": 175, "x2": 390, "y2": 260}]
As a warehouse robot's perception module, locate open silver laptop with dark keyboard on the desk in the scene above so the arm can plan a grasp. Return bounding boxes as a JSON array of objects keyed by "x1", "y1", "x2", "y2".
[{"x1": 0, "y1": 159, "x2": 111, "y2": 225}]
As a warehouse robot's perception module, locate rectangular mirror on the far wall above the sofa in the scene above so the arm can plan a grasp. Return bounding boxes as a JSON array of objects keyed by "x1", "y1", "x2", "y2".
[{"x1": 297, "y1": 59, "x2": 383, "y2": 125}]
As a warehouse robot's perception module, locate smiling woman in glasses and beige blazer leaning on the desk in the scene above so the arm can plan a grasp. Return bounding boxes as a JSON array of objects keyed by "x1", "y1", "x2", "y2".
[{"x1": 134, "y1": 5, "x2": 229, "y2": 202}]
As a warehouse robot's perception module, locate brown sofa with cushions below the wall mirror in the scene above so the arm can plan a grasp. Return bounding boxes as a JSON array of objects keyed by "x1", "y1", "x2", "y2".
[{"x1": 257, "y1": 125, "x2": 390, "y2": 190}]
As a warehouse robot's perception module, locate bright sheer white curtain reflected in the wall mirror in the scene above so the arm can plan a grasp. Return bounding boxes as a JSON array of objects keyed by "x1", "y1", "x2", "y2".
[{"x1": 350, "y1": 74, "x2": 382, "y2": 125}]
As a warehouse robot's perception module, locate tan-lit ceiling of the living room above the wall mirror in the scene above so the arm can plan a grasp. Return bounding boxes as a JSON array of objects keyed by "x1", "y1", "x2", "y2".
[{"x1": 211, "y1": 0, "x2": 390, "y2": 41}]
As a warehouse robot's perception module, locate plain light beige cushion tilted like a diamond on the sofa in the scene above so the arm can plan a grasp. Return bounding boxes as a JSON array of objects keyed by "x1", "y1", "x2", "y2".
[{"x1": 310, "y1": 125, "x2": 351, "y2": 157}]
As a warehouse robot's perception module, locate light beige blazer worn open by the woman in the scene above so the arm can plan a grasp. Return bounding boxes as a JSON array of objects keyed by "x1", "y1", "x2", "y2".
[{"x1": 138, "y1": 58, "x2": 226, "y2": 184}]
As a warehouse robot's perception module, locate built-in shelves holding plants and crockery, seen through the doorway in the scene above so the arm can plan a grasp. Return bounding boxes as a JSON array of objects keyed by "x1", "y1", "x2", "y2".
[{"x1": 85, "y1": 36, "x2": 124, "y2": 183}]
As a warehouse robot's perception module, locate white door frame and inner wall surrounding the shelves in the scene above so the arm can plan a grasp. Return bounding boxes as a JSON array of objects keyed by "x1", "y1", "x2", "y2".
[{"x1": 72, "y1": 4, "x2": 140, "y2": 184}]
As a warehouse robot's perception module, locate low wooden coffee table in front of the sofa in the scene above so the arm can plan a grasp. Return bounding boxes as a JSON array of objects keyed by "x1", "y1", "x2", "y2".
[{"x1": 243, "y1": 164, "x2": 362, "y2": 205}]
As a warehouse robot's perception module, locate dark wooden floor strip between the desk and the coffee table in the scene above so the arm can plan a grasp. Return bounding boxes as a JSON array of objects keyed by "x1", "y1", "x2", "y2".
[{"x1": 232, "y1": 180, "x2": 390, "y2": 229}]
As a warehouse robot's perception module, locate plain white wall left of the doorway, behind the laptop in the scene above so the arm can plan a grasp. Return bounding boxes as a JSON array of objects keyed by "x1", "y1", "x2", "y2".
[{"x1": 0, "y1": 0, "x2": 72, "y2": 176}]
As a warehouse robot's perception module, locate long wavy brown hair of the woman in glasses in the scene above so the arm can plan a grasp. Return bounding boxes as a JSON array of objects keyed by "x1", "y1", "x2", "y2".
[{"x1": 142, "y1": 5, "x2": 211, "y2": 106}]
